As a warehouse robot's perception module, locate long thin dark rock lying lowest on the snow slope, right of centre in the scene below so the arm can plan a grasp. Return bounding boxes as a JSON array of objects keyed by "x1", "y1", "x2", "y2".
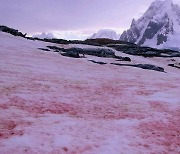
[{"x1": 111, "y1": 63, "x2": 164, "y2": 72}]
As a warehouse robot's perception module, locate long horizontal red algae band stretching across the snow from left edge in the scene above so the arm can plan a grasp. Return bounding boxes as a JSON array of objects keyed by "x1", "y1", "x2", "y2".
[{"x1": 4, "y1": 97, "x2": 147, "y2": 120}]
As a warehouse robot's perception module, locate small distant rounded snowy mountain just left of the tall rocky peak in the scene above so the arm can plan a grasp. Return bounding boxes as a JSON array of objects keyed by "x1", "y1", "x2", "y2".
[{"x1": 90, "y1": 29, "x2": 120, "y2": 40}]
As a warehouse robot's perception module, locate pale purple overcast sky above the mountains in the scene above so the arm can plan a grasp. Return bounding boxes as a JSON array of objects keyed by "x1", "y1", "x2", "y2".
[{"x1": 0, "y1": 0, "x2": 180, "y2": 39}]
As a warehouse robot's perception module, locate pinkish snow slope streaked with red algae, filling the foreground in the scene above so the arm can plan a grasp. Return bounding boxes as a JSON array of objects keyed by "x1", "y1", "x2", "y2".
[{"x1": 0, "y1": 33, "x2": 180, "y2": 154}]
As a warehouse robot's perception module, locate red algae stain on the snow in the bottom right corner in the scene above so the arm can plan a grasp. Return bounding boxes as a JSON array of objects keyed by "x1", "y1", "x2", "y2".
[{"x1": 138, "y1": 107, "x2": 180, "y2": 153}]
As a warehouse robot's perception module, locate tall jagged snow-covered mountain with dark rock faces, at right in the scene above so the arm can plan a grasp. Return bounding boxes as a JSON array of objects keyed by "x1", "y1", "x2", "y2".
[{"x1": 120, "y1": 0, "x2": 180, "y2": 48}]
